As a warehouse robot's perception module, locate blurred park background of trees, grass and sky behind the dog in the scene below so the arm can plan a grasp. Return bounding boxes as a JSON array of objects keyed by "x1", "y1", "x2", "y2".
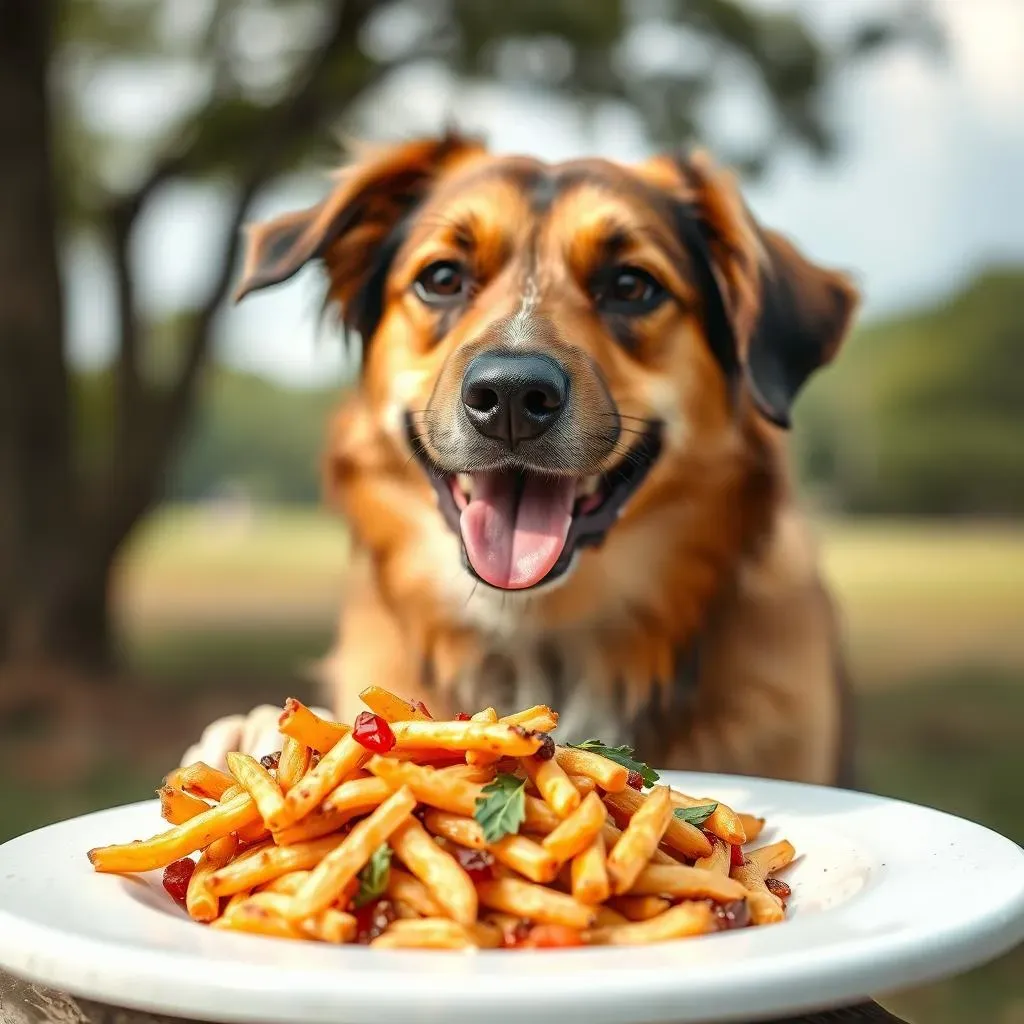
[{"x1": 0, "y1": 0, "x2": 1024, "y2": 1024}]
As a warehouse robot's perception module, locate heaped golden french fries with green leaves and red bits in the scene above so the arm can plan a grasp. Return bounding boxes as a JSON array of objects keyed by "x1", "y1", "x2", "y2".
[{"x1": 89, "y1": 687, "x2": 795, "y2": 949}]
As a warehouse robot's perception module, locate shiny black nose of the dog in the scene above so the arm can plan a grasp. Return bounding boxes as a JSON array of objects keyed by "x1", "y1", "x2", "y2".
[{"x1": 462, "y1": 352, "x2": 569, "y2": 449}]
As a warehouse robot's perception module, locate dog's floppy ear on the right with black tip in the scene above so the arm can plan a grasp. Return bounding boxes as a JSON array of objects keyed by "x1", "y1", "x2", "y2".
[{"x1": 639, "y1": 153, "x2": 858, "y2": 428}]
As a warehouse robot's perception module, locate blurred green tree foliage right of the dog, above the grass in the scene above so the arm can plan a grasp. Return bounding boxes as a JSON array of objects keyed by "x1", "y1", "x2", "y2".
[{"x1": 797, "y1": 267, "x2": 1024, "y2": 515}]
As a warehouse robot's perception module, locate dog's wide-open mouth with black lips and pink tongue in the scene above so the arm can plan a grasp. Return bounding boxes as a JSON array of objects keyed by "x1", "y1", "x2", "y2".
[{"x1": 408, "y1": 420, "x2": 662, "y2": 590}]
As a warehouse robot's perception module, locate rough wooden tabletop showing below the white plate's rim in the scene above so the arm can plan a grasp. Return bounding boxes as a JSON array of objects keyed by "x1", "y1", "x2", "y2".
[{"x1": 0, "y1": 971, "x2": 905, "y2": 1024}]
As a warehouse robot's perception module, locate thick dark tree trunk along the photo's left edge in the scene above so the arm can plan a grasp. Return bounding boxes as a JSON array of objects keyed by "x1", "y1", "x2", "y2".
[{"x1": 0, "y1": 0, "x2": 110, "y2": 689}]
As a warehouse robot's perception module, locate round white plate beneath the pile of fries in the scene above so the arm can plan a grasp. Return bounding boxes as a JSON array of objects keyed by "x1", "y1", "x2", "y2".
[{"x1": 0, "y1": 772, "x2": 1024, "y2": 1024}]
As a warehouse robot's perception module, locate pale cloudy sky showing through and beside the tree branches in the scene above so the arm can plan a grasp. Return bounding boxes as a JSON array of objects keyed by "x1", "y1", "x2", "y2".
[{"x1": 67, "y1": 0, "x2": 1024, "y2": 386}]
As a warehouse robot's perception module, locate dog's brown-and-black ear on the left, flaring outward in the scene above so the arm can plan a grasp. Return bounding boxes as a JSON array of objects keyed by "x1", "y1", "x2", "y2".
[{"x1": 234, "y1": 133, "x2": 484, "y2": 337}]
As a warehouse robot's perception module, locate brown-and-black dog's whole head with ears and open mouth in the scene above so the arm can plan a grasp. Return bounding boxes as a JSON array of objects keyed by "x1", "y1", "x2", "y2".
[{"x1": 240, "y1": 136, "x2": 855, "y2": 590}]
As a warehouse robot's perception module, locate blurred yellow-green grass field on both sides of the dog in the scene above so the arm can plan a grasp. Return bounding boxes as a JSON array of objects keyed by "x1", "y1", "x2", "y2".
[{"x1": 0, "y1": 509, "x2": 1024, "y2": 1024}]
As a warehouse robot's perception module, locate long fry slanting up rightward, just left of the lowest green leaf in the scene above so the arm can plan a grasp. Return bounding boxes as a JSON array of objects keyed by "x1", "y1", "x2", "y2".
[{"x1": 288, "y1": 782, "x2": 415, "y2": 921}]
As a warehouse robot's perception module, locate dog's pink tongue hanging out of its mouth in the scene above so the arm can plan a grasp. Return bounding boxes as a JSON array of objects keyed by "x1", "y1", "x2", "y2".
[{"x1": 461, "y1": 473, "x2": 575, "y2": 590}]
